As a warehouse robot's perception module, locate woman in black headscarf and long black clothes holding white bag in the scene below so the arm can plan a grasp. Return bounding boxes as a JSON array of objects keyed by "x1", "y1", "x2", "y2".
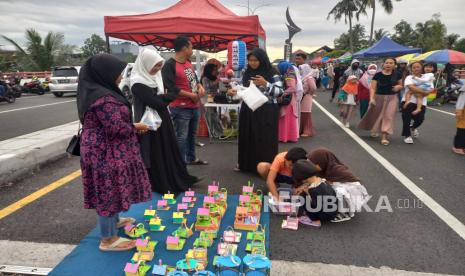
[{"x1": 228, "y1": 48, "x2": 284, "y2": 172}]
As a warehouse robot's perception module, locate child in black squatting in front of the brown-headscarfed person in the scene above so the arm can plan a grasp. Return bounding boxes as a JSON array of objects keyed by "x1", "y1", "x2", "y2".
[{"x1": 292, "y1": 160, "x2": 338, "y2": 227}]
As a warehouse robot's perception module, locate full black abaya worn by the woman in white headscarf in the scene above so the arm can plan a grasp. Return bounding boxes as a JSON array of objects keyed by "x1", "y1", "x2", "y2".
[{"x1": 131, "y1": 83, "x2": 198, "y2": 194}]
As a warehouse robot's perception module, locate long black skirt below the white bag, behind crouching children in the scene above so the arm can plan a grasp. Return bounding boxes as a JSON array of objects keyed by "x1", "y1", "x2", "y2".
[{"x1": 239, "y1": 103, "x2": 279, "y2": 172}]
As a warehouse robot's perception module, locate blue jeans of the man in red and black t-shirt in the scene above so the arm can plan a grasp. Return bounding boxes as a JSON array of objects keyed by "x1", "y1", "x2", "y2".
[{"x1": 170, "y1": 107, "x2": 200, "y2": 163}]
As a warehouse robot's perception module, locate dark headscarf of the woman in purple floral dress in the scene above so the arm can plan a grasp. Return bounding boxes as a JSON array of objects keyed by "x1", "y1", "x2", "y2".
[{"x1": 76, "y1": 54, "x2": 132, "y2": 122}]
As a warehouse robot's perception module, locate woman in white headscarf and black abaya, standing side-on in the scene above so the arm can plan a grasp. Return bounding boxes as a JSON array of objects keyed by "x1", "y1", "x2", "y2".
[{"x1": 130, "y1": 48, "x2": 197, "y2": 194}]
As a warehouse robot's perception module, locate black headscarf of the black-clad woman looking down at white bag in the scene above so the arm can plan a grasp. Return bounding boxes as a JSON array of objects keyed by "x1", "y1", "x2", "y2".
[{"x1": 242, "y1": 48, "x2": 278, "y2": 86}]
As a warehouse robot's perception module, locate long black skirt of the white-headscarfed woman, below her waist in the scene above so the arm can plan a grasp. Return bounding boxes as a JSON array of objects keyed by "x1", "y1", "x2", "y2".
[{"x1": 140, "y1": 108, "x2": 198, "y2": 194}]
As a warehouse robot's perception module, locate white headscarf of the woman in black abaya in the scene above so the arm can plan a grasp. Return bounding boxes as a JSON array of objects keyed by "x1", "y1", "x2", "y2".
[{"x1": 130, "y1": 47, "x2": 165, "y2": 94}]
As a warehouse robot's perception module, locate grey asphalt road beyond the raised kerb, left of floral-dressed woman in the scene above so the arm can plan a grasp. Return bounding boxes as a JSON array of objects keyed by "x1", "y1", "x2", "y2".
[{"x1": 0, "y1": 93, "x2": 77, "y2": 141}]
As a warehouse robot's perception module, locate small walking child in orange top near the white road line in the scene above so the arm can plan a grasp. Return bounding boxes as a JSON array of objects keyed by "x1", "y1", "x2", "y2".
[{"x1": 340, "y1": 75, "x2": 358, "y2": 128}]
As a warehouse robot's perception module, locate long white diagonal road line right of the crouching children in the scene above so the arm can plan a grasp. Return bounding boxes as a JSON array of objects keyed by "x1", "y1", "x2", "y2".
[{"x1": 313, "y1": 100, "x2": 465, "y2": 240}]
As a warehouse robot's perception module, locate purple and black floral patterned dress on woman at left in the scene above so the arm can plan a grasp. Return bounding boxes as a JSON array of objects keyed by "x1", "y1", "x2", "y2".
[{"x1": 81, "y1": 96, "x2": 152, "y2": 217}]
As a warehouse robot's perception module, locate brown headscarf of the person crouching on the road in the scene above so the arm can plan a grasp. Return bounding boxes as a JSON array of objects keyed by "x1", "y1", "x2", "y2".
[{"x1": 307, "y1": 148, "x2": 360, "y2": 183}]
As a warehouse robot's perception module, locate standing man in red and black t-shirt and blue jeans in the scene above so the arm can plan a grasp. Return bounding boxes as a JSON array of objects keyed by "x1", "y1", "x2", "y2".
[{"x1": 162, "y1": 37, "x2": 208, "y2": 165}]
